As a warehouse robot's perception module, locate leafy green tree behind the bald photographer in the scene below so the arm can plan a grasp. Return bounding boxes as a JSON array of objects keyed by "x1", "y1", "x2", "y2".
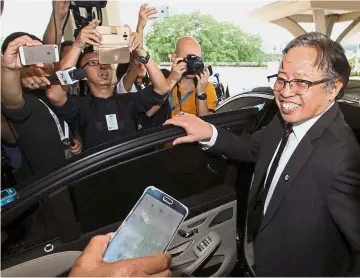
[{"x1": 145, "y1": 12, "x2": 264, "y2": 62}]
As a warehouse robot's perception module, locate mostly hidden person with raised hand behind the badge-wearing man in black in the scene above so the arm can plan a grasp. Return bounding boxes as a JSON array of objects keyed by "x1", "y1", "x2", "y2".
[{"x1": 116, "y1": 4, "x2": 157, "y2": 94}]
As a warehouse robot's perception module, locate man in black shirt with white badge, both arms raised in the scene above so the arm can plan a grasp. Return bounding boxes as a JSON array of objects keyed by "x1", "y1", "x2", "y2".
[{"x1": 47, "y1": 21, "x2": 169, "y2": 149}]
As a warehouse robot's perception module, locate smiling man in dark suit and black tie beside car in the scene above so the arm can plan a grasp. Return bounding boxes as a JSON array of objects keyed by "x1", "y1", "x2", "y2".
[{"x1": 167, "y1": 33, "x2": 360, "y2": 276}]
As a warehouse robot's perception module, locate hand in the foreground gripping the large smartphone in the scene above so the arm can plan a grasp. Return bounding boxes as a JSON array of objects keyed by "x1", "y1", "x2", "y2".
[{"x1": 70, "y1": 234, "x2": 171, "y2": 277}]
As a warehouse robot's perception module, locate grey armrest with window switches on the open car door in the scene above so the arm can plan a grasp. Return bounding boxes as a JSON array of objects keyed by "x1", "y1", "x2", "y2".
[{"x1": 172, "y1": 232, "x2": 221, "y2": 277}]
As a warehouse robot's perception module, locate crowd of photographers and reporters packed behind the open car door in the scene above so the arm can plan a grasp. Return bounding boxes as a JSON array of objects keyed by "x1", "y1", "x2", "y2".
[{"x1": 1, "y1": 1, "x2": 216, "y2": 181}]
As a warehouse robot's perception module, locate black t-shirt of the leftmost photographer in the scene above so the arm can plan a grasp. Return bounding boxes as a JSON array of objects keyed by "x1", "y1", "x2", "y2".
[{"x1": 2, "y1": 90, "x2": 66, "y2": 177}]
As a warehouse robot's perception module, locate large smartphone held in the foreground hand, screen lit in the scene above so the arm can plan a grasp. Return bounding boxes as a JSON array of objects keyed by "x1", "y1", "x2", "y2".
[{"x1": 104, "y1": 186, "x2": 188, "y2": 262}]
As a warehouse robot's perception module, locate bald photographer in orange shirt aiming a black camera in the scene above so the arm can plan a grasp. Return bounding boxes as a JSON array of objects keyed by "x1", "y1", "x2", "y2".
[{"x1": 167, "y1": 37, "x2": 217, "y2": 117}]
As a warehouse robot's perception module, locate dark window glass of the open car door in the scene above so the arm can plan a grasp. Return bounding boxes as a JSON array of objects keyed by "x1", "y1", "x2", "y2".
[{"x1": 69, "y1": 145, "x2": 227, "y2": 232}]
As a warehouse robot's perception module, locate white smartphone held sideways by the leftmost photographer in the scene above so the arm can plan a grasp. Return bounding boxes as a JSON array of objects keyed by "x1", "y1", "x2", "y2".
[{"x1": 19, "y1": 44, "x2": 59, "y2": 66}]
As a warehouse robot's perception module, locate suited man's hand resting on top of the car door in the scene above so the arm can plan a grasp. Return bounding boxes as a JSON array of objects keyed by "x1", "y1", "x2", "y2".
[{"x1": 164, "y1": 113, "x2": 213, "y2": 146}]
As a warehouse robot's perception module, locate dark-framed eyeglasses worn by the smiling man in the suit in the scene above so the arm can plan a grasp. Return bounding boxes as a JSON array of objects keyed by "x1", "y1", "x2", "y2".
[{"x1": 267, "y1": 74, "x2": 330, "y2": 95}]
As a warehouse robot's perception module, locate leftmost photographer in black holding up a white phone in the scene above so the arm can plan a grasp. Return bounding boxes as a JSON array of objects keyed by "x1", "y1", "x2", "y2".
[{"x1": 1, "y1": 32, "x2": 81, "y2": 177}]
